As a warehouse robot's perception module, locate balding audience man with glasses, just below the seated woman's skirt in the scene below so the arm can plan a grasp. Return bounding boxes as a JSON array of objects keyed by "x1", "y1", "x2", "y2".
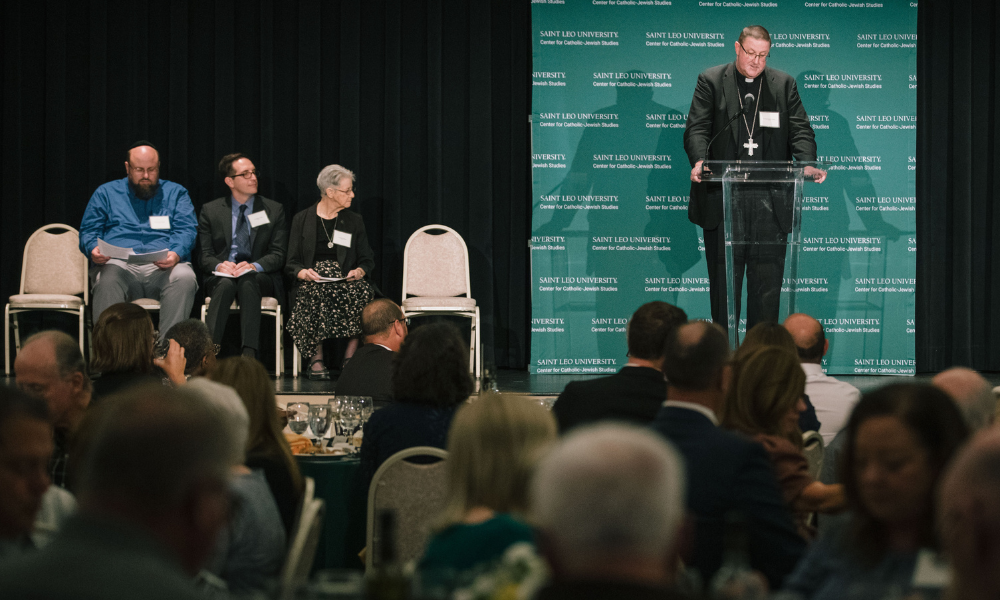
[{"x1": 337, "y1": 298, "x2": 409, "y2": 408}]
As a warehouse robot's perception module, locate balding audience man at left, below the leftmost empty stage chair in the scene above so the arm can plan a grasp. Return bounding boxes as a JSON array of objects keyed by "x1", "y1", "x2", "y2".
[{"x1": 14, "y1": 331, "x2": 91, "y2": 488}]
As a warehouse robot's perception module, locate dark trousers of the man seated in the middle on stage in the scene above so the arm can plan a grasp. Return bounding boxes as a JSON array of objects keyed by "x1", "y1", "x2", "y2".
[{"x1": 205, "y1": 273, "x2": 274, "y2": 351}]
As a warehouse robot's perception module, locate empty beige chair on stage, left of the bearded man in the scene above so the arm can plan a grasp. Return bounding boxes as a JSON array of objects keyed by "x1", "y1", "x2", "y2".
[{"x1": 3, "y1": 223, "x2": 90, "y2": 375}]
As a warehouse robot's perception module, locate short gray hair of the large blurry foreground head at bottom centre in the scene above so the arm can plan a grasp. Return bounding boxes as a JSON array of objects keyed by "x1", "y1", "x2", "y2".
[{"x1": 531, "y1": 423, "x2": 685, "y2": 573}]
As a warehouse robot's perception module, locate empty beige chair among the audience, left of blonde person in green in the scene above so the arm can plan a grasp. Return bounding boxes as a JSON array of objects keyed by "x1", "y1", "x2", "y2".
[{"x1": 365, "y1": 446, "x2": 448, "y2": 571}]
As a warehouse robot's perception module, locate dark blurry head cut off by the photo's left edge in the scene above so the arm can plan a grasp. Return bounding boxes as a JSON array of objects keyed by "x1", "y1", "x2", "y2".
[{"x1": 0, "y1": 386, "x2": 52, "y2": 540}]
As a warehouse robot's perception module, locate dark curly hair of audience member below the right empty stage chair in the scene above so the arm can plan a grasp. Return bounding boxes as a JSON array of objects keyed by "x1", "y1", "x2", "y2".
[{"x1": 392, "y1": 322, "x2": 473, "y2": 408}]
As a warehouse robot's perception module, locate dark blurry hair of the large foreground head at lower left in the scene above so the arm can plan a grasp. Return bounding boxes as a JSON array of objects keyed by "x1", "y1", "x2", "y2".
[{"x1": 76, "y1": 384, "x2": 236, "y2": 515}]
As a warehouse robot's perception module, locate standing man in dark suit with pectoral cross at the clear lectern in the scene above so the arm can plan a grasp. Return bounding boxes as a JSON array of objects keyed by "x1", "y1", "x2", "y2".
[{"x1": 684, "y1": 25, "x2": 826, "y2": 329}]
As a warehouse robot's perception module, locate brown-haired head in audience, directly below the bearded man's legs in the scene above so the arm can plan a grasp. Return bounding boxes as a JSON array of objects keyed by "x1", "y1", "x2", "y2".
[{"x1": 90, "y1": 302, "x2": 156, "y2": 373}]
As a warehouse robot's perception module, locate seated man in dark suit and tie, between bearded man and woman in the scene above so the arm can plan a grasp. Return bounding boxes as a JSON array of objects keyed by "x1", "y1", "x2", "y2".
[{"x1": 198, "y1": 154, "x2": 288, "y2": 358}]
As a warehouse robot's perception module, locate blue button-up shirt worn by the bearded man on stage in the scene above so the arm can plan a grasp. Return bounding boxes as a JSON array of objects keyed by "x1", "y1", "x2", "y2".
[{"x1": 80, "y1": 177, "x2": 198, "y2": 261}]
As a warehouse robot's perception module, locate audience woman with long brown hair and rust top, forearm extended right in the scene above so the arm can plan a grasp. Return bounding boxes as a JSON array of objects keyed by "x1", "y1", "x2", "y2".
[{"x1": 719, "y1": 346, "x2": 844, "y2": 540}]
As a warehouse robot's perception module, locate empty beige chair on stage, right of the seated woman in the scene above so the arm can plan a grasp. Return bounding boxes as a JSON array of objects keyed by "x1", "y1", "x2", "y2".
[{"x1": 401, "y1": 225, "x2": 483, "y2": 379}]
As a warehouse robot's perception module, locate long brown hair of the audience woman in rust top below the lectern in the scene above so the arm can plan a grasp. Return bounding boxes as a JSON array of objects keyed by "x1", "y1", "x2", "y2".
[{"x1": 719, "y1": 346, "x2": 806, "y2": 445}]
